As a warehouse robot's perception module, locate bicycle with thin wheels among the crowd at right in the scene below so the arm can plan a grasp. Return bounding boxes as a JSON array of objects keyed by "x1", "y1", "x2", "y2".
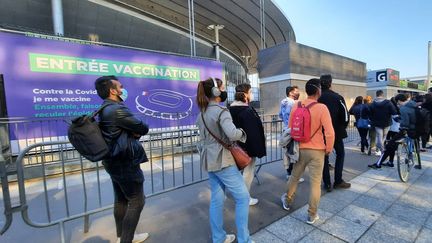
[{"x1": 396, "y1": 136, "x2": 421, "y2": 182}]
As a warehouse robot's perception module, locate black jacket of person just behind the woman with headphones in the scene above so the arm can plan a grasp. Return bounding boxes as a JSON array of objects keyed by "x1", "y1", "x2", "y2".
[{"x1": 229, "y1": 106, "x2": 266, "y2": 158}]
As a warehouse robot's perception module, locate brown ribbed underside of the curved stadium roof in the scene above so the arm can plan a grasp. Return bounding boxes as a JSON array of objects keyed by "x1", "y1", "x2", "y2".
[{"x1": 106, "y1": 0, "x2": 295, "y2": 71}]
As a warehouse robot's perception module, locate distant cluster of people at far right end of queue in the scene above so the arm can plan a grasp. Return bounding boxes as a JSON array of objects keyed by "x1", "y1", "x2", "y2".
[{"x1": 350, "y1": 89, "x2": 432, "y2": 169}]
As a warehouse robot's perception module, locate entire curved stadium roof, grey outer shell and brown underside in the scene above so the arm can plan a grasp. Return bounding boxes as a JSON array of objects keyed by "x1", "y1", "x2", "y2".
[{"x1": 0, "y1": 0, "x2": 295, "y2": 73}]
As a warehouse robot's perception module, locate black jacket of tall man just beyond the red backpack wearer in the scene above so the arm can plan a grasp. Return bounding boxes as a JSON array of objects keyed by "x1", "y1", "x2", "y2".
[{"x1": 318, "y1": 89, "x2": 349, "y2": 139}]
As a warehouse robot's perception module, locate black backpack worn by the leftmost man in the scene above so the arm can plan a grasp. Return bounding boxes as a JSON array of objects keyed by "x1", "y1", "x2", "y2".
[{"x1": 68, "y1": 104, "x2": 111, "y2": 162}]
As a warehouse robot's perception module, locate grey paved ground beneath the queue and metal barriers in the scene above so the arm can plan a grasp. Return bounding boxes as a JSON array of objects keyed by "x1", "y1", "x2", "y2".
[{"x1": 0, "y1": 140, "x2": 432, "y2": 243}]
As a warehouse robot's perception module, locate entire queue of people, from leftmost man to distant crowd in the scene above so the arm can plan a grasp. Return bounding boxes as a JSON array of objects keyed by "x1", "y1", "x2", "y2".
[{"x1": 95, "y1": 75, "x2": 432, "y2": 243}]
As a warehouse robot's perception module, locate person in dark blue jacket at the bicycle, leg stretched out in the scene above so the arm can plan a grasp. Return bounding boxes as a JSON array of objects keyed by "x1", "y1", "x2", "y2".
[{"x1": 368, "y1": 94, "x2": 421, "y2": 169}]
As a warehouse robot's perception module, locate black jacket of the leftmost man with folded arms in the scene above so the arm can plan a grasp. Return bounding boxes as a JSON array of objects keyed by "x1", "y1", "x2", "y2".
[{"x1": 99, "y1": 99, "x2": 149, "y2": 166}]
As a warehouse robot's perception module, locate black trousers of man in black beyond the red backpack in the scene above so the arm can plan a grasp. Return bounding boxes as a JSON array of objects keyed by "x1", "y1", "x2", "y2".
[{"x1": 322, "y1": 138, "x2": 345, "y2": 186}]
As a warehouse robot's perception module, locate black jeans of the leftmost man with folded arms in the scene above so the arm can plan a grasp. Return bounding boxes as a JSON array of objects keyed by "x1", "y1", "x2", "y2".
[{"x1": 112, "y1": 180, "x2": 145, "y2": 243}]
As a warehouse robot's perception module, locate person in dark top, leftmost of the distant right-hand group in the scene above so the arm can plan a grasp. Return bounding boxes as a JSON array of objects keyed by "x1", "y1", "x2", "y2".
[{"x1": 349, "y1": 96, "x2": 369, "y2": 153}]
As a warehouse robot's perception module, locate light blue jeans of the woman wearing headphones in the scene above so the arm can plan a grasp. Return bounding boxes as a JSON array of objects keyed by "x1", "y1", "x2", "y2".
[{"x1": 208, "y1": 166, "x2": 251, "y2": 243}]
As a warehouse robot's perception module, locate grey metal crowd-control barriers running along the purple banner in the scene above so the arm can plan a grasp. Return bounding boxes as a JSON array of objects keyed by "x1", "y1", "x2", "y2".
[{"x1": 0, "y1": 118, "x2": 358, "y2": 242}]
